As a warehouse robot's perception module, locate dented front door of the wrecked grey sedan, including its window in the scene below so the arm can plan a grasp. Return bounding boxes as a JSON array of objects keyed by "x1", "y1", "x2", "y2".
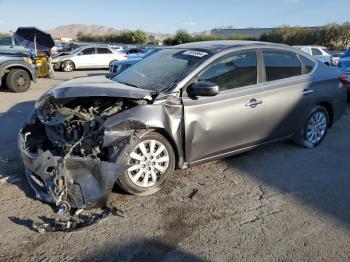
[{"x1": 183, "y1": 50, "x2": 264, "y2": 162}]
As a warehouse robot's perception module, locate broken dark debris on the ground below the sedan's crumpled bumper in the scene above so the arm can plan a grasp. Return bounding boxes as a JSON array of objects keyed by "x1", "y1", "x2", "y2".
[{"x1": 32, "y1": 207, "x2": 125, "y2": 234}]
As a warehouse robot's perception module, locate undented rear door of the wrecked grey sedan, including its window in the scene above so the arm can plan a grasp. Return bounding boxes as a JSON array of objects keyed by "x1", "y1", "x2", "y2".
[{"x1": 261, "y1": 49, "x2": 314, "y2": 141}]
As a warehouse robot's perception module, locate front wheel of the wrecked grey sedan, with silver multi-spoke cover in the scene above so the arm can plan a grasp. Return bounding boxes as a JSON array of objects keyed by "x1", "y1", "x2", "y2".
[{"x1": 116, "y1": 132, "x2": 175, "y2": 195}]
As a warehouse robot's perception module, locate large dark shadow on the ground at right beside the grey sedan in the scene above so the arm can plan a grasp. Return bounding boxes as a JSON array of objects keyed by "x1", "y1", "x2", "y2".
[{"x1": 223, "y1": 109, "x2": 350, "y2": 229}]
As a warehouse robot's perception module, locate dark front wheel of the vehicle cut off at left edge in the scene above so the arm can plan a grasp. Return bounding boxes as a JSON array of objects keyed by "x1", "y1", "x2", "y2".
[{"x1": 6, "y1": 69, "x2": 31, "y2": 93}]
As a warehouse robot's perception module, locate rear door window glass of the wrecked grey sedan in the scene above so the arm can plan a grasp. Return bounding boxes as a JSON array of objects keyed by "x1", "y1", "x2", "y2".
[{"x1": 263, "y1": 51, "x2": 301, "y2": 81}]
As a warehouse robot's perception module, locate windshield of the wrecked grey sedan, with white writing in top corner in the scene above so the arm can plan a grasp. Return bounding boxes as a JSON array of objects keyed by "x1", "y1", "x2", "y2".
[{"x1": 112, "y1": 48, "x2": 210, "y2": 91}]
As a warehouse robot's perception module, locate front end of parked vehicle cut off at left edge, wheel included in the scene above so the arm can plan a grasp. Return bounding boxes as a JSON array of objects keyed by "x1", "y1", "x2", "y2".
[{"x1": 0, "y1": 52, "x2": 37, "y2": 93}]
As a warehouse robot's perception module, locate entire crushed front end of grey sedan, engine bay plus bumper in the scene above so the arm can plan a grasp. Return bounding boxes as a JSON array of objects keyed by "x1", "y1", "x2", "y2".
[{"x1": 19, "y1": 96, "x2": 146, "y2": 210}]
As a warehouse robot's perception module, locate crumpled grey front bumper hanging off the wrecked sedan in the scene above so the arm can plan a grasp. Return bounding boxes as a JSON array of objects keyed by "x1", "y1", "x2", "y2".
[{"x1": 18, "y1": 131, "x2": 127, "y2": 208}]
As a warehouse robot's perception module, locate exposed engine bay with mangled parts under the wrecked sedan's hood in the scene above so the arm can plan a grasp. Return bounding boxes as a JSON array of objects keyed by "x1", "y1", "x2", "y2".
[{"x1": 32, "y1": 97, "x2": 147, "y2": 161}]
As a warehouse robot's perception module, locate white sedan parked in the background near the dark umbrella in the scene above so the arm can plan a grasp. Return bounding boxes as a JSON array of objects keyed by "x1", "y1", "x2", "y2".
[{"x1": 52, "y1": 46, "x2": 127, "y2": 72}]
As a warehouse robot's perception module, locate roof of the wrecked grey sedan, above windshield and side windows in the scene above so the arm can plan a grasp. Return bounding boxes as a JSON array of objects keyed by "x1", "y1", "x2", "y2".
[{"x1": 173, "y1": 40, "x2": 287, "y2": 52}]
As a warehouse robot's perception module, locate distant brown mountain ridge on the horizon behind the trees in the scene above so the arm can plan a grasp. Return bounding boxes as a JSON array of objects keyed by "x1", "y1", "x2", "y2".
[{"x1": 48, "y1": 24, "x2": 171, "y2": 40}]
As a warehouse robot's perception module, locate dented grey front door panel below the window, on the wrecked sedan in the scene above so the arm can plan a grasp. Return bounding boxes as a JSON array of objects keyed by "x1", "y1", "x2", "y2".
[{"x1": 183, "y1": 86, "x2": 264, "y2": 162}]
